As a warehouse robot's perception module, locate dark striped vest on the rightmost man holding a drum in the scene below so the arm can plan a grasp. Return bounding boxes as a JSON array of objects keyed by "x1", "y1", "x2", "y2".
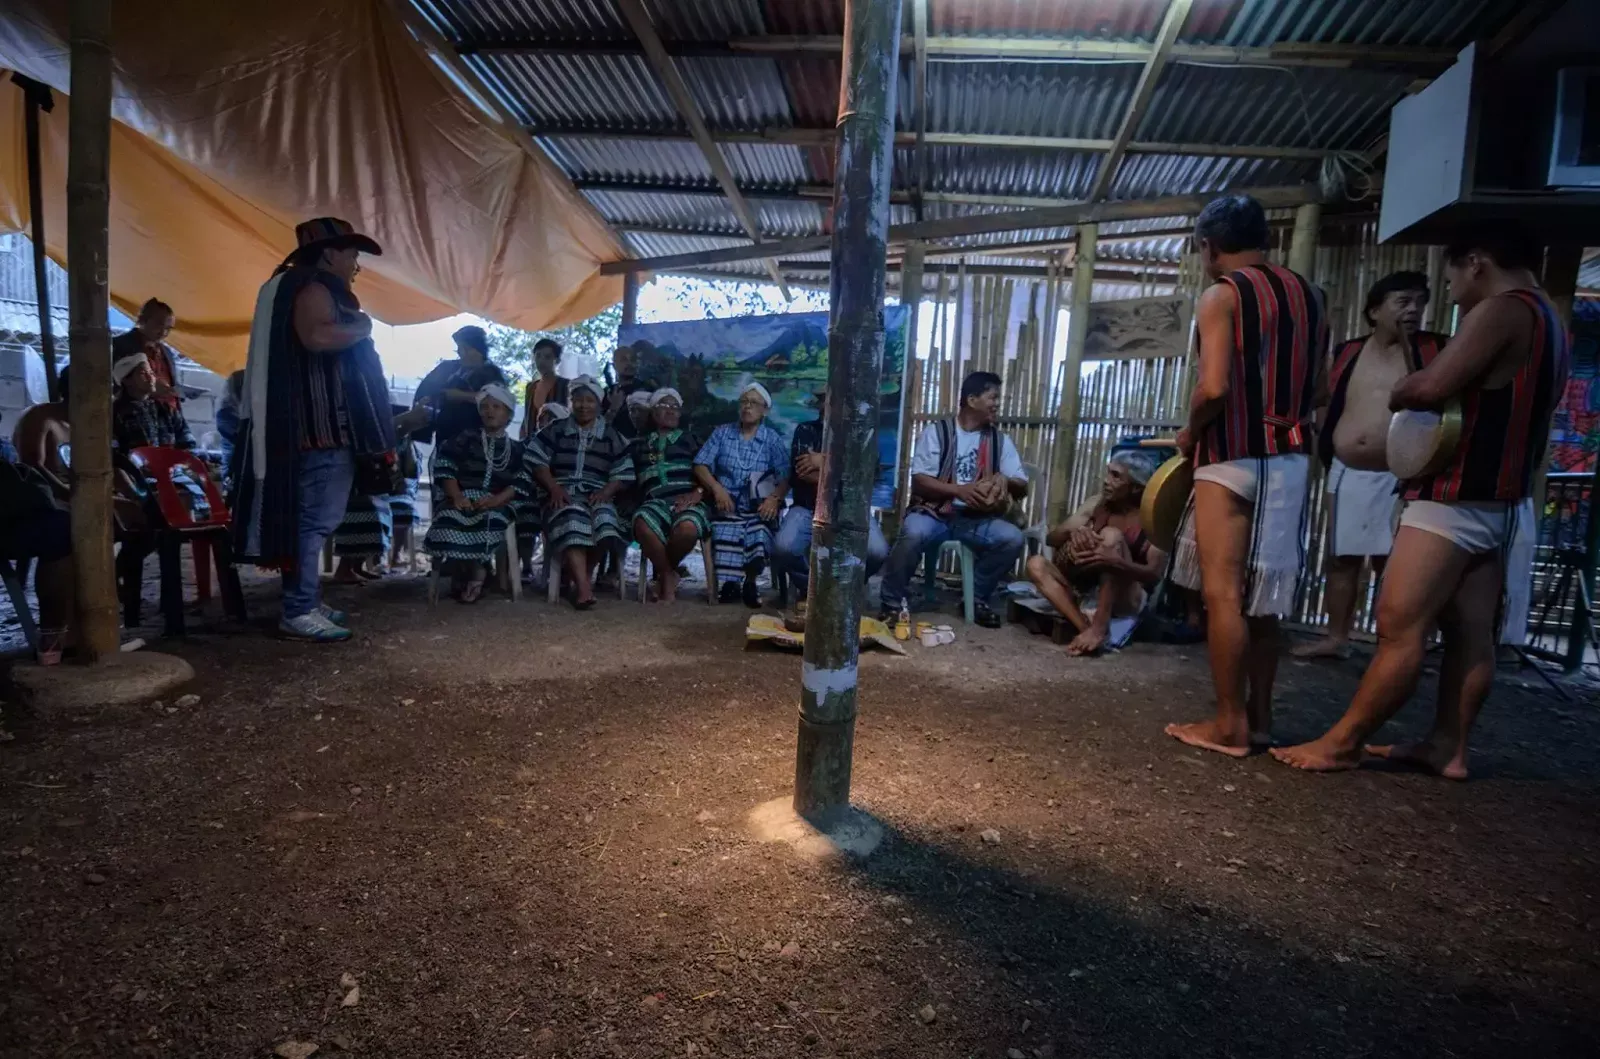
[{"x1": 1403, "y1": 290, "x2": 1571, "y2": 502}]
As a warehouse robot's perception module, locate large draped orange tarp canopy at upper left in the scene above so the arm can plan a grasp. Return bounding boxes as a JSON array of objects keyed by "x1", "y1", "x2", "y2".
[{"x1": 0, "y1": 0, "x2": 622, "y2": 374}]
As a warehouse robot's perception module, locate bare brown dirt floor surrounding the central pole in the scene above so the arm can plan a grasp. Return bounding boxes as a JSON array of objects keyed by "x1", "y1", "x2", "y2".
[{"x1": 0, "y1": 581, "x2": 1600, "y2": 1059}]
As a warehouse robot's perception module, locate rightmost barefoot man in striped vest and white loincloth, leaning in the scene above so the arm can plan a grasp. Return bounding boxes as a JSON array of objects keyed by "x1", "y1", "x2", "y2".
[{"x1": 1272, "y1": 222, "x2": 1568, "y2": 779}]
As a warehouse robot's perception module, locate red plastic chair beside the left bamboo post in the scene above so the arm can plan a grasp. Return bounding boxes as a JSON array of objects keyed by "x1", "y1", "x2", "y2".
[{"x1": 123, "y1": 446, "x2": 245, "y2": 637}]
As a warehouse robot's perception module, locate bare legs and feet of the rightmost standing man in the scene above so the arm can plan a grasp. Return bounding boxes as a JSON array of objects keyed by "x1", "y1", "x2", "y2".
[{"x1": 1272, "y1": 526, "x2": 1502, "y2": 779}]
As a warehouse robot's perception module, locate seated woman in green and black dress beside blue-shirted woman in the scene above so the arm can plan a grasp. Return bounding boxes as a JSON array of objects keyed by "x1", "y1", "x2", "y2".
[{"x1": 634, "y1": 387, "x2": 710, "y2": 603}]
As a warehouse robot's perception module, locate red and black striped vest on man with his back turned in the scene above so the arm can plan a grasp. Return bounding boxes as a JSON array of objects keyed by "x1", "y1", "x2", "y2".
[{"x1": 1195, "y1": 264, "x2": 1328, "y2": 467}]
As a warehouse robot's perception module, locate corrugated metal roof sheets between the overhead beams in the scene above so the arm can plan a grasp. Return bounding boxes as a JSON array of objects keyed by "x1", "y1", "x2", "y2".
[{"x1": 413, "y1": 0, "x2": 1548, "y2": 286}]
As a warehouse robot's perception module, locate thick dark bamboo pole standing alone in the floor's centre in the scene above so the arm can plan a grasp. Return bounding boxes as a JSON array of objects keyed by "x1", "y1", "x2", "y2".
[{"x1": 794, "y1": 0, "x2": 901, "y2": 816}]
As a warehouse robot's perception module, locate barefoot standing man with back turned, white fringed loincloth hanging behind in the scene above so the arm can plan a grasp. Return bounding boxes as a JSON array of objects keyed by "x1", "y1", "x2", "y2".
[{"x1": 1166, "y1": 195, "x2": 1328, "y2": 757}]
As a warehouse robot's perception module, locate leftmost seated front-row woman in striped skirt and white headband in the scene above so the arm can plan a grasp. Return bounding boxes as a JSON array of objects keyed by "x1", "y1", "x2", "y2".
[{"x1": 424, "y1": 382, "x2": 523, "y2": 603}]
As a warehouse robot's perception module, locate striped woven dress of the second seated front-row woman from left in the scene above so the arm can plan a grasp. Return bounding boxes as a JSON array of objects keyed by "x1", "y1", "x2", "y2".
[{"x1": 522, "y1": 419, "x2": 634, "y2": 555}]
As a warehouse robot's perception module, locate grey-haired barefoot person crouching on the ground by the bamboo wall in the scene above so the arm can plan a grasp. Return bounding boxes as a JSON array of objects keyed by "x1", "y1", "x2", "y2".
[{"x1": 1027, "y1": 451, "x2": 1166, "y2": 654}]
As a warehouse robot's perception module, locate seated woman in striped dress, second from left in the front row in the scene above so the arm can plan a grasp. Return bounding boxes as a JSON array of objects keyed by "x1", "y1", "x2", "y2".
[{"x1": 525, "y1": 374, "x2": 634, "y2": 611}]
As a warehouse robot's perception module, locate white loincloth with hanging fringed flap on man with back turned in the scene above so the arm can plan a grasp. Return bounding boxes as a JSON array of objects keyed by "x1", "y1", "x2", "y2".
[{"x1": 1171, "y1": 453, "x2": 1310, "y2": 617}]
